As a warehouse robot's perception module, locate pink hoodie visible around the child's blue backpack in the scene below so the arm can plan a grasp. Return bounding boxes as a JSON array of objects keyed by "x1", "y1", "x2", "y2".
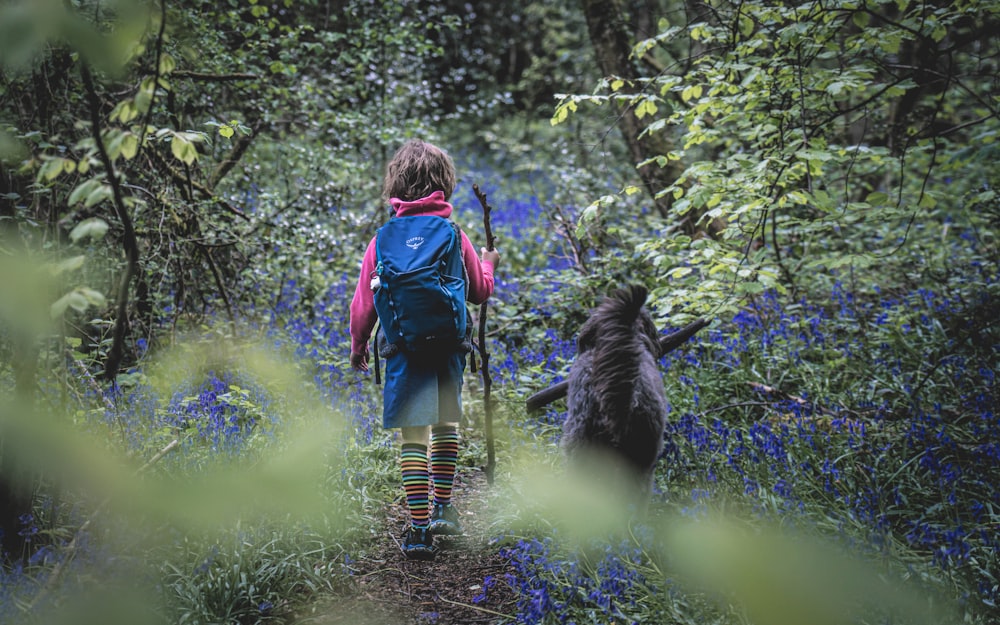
[{"x1": 351, "y1": 191, "x2": 493, "y2": 354}]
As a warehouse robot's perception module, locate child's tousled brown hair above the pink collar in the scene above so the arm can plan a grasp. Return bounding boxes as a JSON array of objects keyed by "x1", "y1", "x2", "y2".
[{"x1": 382, "y1": 139, "x2": 455, "y2": 202}]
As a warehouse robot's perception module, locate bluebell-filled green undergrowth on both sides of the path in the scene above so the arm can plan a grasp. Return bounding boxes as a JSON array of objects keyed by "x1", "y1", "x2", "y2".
[{"x1": 0, "y1": 177, "x2": 1000, "y2": 624}]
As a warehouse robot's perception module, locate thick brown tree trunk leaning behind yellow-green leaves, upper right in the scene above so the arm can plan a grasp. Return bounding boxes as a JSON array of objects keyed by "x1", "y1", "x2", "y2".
[{"x1": 581, "y1": 0, "x2": 697, "y2": 234}]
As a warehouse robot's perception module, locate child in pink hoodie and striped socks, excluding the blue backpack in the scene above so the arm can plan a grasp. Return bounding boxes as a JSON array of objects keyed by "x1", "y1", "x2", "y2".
[{"x1": 351, "y1": 140, "x2": 500, "y2": 560}]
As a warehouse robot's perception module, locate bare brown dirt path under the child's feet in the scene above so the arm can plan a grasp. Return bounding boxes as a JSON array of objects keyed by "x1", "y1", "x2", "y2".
[{"x1": 299, "y1": 469, "x2": 515, "y2": 625}]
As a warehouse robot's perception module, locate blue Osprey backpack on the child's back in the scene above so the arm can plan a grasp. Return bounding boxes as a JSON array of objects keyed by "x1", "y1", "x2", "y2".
[{"x1": 373, "y1": 215, "x2": 467, "y2": 352}]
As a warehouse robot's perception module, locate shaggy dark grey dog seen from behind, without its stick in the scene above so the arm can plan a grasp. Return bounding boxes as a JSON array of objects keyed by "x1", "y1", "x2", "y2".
[{"x1": 562, "y1": 285, "x2": 667, "y2": 502}]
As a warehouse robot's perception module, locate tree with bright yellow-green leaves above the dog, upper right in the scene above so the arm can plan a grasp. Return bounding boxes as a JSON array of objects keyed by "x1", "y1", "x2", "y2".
[{"x1": 554, "y1": 0, "x2": 1000, "y2": 320}]
